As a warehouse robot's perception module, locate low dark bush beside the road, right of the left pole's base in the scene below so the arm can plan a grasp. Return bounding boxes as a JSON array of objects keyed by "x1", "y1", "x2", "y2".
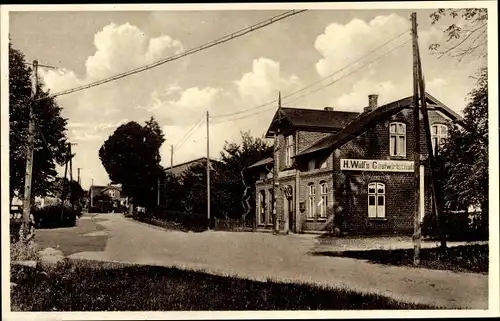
[{"x1": 33, "y1": 205, "x2": 81, "y2": 228}]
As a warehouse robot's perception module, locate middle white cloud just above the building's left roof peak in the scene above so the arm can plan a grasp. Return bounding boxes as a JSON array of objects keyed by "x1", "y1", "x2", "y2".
[{"x1": 235, "y1": 57, "x2": 301, "y2": 104}]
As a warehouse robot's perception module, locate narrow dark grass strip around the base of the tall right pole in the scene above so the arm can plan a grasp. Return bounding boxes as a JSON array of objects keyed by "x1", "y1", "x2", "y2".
[{"x1": 315, "y1": 245, "x2": 489, "y2": 273}]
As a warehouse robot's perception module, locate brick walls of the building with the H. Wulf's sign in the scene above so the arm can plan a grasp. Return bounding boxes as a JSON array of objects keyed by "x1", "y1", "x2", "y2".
[{"x1": 256, "y1": 109, "x2": 448, "y2": 233}]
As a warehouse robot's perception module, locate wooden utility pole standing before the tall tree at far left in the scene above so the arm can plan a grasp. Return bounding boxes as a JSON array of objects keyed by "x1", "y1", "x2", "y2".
[{"x1": 20, "y1": 60, "x2": 38, "y2": 242}]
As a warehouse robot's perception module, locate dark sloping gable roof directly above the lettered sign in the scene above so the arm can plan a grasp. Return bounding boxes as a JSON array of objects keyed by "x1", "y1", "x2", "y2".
[{"x1": 295, "y1": 93, "x2": 462, "y2": 157}]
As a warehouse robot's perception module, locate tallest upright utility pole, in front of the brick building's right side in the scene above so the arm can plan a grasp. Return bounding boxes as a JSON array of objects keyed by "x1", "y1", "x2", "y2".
[{"x1": 411, "y1": 12, "x2": 421, "y2": 265}]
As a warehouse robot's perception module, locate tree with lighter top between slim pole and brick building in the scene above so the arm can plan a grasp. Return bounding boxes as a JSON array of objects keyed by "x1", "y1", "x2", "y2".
[{"x1": 213, "y1": 132, "x2": 273, "y2": 219}]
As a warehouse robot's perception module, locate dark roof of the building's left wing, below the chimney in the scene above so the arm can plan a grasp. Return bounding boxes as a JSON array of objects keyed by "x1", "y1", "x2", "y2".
[{"x1": 266, "y1": 107, "x2": 359, "y2": 138}]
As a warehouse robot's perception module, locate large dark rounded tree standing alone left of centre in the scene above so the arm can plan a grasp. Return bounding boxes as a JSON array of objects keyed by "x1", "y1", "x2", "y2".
[{"x1": 99, "y1": 117, "x2": 165, "y2": 207}]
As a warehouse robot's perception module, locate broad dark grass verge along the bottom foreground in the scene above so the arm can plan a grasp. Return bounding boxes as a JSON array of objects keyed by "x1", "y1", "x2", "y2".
[{"x1": 11, "y1": 260, "x2": 436, "y2": 311}]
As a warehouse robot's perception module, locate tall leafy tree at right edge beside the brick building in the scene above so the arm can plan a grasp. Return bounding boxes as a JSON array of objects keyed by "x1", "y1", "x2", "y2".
[{"x1": 437, "y1": 68, "x2": 489, "y2": 227}]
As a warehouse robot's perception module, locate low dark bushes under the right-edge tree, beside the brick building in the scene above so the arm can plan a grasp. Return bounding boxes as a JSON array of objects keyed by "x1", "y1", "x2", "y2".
[{"x1": 422, "y1": 211, "x2": 488, "y2": 241}]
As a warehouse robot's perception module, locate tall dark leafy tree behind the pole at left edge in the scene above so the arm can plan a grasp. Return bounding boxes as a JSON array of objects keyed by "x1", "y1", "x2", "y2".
[{"x1": 9, "y1": 43, "x2": 67, "y2": 202}]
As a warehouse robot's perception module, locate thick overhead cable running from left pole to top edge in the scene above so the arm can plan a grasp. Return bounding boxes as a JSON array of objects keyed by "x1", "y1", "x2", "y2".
[{"x1": 40, "y1": 10, "x2": 307, "y2": 98}]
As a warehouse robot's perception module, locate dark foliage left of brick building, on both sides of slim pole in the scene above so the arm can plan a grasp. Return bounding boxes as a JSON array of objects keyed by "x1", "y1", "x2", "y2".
[{"x1": 165, "y1": 132, "x2": 272, "y2": 219}]
